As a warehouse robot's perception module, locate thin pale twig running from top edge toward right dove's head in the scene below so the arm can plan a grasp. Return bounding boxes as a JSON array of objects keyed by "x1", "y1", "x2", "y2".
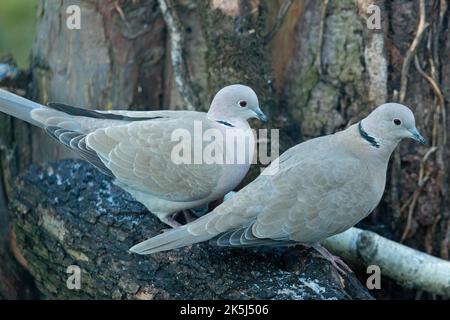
[{"x1": 399, "y1": 0, "x2": 429, "y2": 103}]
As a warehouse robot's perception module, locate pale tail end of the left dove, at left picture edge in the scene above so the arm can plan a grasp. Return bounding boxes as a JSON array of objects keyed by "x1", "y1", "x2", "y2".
[{"x1": 0, "y1": 89, "x2": 43, "y2": 127}]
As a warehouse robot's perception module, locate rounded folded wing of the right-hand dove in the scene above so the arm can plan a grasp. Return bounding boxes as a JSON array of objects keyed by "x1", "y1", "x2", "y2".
[{"x1": 251, "y1": 152, "x2": 372, "y2": 243}]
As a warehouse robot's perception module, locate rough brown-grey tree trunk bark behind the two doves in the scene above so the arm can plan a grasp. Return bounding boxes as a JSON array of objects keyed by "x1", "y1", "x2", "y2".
[{"x1": 0, "y1": 0, "x2": 450, "y2": 300}]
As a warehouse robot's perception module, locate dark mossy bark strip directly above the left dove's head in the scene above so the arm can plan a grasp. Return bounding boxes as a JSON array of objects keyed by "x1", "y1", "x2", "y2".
[{"x1": 200, "y1": 0, "x2": 274, "y2": 106}]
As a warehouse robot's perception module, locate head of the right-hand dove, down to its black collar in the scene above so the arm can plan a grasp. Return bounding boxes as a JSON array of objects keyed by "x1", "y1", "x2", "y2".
[{"x1": 359, "y1": 103, "x2": 426, "y2": 147}]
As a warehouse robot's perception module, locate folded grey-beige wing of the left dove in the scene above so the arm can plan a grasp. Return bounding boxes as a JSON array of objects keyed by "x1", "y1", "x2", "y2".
[{"x1": 86, "y1": 118, "x2": 223, "y2": 201}]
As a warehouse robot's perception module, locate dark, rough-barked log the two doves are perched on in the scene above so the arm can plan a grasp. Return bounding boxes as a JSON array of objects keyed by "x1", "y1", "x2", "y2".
[{"x1": 7, "y1": 160, "x2": 372, "y2": 299}]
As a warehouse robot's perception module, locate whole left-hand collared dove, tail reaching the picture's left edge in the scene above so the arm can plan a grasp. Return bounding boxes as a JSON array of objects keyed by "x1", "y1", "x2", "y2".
[{"x1": 0, "y1": 84, "x2": 266, "y2": 226}]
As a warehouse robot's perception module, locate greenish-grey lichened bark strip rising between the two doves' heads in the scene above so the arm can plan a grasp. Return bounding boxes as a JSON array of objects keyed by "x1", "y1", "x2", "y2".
[{"x1": 289, "y1": 0, "x2": 367, "y2": 138}]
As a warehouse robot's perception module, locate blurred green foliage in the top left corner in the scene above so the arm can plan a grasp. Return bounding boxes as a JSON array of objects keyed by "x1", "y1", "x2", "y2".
[{"x1": 0, "y1": 0, "x2": 37, "y2": 68}]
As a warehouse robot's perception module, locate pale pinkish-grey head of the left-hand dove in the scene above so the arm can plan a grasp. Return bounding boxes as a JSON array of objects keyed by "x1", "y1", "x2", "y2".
[{"x1": 208, "y1": 84, "x2": 267, "y2": 125}]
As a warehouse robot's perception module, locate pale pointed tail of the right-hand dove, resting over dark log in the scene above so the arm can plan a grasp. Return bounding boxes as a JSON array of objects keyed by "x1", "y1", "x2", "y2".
[{"x1": 130, "y1": 225, "x2": 215, "y2": 254}]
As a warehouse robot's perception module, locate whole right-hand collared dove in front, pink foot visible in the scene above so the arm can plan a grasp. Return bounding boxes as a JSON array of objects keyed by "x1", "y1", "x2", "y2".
[{"x1": 130, "y1": 103, "x2": 425, "y2": 271}]
